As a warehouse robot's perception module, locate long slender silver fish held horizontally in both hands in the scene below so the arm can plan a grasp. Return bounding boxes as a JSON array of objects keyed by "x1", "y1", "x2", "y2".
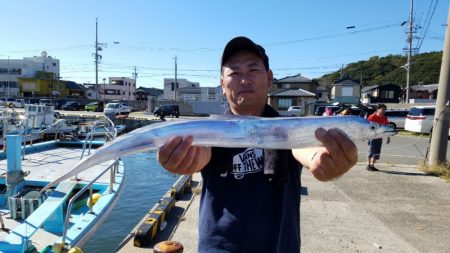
[{"x1": 41, "y1": 116, "x2": 396, "y2": 192}]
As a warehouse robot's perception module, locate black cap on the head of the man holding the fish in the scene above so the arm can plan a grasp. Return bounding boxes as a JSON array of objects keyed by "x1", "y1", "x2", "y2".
[{"x1": 220, "y1": 36, "x2": 269, "y2": 70}]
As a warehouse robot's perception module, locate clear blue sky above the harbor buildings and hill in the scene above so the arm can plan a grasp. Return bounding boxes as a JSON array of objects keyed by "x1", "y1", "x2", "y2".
[{"x1": 0, "y1": 0, "x2": 450, "y2": 88}]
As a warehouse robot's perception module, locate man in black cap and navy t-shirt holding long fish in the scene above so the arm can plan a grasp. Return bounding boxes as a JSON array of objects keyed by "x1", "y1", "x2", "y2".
[{"x1": 158, "y1": 37, "x2": 357, "y2": 252}]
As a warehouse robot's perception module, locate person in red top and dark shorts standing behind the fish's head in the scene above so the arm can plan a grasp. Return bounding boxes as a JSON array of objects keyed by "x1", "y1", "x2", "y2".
[{"x1": 366, "y1": 104, "x2": 391, "y2": 171}]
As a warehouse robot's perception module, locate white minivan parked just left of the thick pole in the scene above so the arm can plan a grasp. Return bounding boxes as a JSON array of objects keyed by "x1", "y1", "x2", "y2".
[{"x1": 405, "y1": 106, "x2": 446, "y2": 133}]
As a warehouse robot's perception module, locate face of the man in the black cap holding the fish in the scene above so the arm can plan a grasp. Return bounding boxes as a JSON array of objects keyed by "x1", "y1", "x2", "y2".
[{"x1": 220, "y1": 51, "x2": 273, "y2": 116}]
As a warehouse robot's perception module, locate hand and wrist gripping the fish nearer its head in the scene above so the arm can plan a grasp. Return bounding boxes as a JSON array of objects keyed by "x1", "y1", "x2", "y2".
[{"x1": 292, "y1": 128, "x2": 358, "y2": 181}]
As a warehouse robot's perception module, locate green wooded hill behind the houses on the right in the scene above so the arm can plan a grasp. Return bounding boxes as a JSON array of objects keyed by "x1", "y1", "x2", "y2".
[{"x1": 319, "y1": 51, "x2": 442, "y2": 87}]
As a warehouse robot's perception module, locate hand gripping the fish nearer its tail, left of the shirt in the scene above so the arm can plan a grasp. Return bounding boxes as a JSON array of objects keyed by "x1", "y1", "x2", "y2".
[{"x1": 157, "y1": 136, "x2": 211, "y2": 174}]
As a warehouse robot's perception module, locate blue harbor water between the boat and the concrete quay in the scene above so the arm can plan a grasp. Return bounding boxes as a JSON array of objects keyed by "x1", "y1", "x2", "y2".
[{"x1": 83, "y1": 152, "x2": 179, "y2": 253}]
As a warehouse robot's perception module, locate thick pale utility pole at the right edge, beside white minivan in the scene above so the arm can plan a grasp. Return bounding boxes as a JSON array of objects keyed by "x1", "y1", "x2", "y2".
[{"x1": 428, "y1": 8, "x2": 450, "y2": 165}]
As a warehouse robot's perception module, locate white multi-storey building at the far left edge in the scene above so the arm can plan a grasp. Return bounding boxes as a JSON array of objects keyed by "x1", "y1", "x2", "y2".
[{"x1": 0, "y1": 51, "x2": 60, "y2": 98}]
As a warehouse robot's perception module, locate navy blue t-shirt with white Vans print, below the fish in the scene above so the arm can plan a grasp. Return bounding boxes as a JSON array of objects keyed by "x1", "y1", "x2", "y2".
[{"x1": 199, "y1": 148, "x2": 301, "y2": 253}]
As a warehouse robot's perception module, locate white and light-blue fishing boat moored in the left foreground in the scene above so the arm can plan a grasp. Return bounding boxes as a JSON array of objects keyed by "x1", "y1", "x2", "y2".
[{"x1": 0, "y1": 119, "x2": 124, "y2": 253}]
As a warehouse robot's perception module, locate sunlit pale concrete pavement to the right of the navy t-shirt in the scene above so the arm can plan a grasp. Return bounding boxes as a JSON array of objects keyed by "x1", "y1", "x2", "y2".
[{"x1": 301, "y1": 163, "x2": 450, "y2": 252}]
